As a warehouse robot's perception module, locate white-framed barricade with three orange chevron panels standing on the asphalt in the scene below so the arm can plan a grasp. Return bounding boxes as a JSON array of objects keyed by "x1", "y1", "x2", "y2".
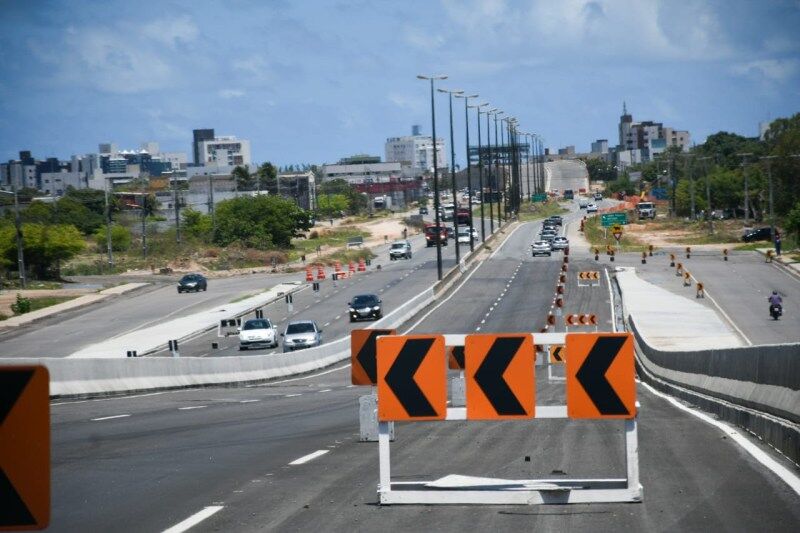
[{"x1": 377, "y1": 333, "x2": 643, "y2": 505}]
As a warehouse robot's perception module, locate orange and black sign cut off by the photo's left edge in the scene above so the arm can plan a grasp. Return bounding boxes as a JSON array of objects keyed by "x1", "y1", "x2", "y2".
[{"x1": 0, "y1": 366, "x2": 50, "y2": 531}]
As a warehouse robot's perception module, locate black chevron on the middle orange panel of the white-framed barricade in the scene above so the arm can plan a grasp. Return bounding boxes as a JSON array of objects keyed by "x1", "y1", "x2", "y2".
[{"x1": 475, "y1": 337, "x2": 526, "y2": 415}]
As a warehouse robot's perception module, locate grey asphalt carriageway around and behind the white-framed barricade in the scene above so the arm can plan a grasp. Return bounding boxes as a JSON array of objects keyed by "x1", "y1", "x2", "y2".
[{"x1": 43, "y1": 213, "x2": 800, "y2": 532}]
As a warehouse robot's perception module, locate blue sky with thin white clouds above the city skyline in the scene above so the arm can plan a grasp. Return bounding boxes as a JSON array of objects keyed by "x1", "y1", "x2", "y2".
[{"x1": 0, "y1": 0, "x2": 800, "y2": 165}]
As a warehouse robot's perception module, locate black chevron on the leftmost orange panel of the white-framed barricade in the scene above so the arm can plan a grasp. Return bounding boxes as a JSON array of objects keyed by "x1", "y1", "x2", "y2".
[{"x1": 386, "y1": 339, "x2": 436, "y2": 417}]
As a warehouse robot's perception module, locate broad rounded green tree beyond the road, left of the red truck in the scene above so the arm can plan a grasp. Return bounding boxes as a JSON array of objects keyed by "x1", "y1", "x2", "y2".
[{"x1": 214, "y1": 195, "x2": 311, "y2": 250}]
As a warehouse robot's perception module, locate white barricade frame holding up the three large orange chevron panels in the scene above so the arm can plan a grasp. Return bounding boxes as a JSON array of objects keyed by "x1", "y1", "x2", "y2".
[{"x1": 378, "y1": 333, "x2": 644, "y2": 505}]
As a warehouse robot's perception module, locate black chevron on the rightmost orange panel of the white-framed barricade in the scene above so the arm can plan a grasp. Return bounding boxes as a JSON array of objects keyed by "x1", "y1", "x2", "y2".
[{"x1": 575, "y1": 337, "x2": 630, "y2": 415}]
